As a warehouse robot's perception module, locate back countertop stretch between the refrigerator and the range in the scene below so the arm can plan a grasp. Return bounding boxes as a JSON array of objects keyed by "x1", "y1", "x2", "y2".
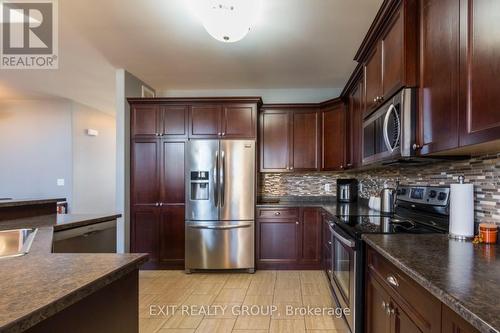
[{"x1": 257, "y1": 196, "x2": 381, "y2": 216}]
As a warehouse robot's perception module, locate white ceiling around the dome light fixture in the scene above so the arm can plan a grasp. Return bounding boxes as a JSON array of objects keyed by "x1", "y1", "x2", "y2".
[{"x1": 0, "y1": 0, "x2": 382, "y2": 108}]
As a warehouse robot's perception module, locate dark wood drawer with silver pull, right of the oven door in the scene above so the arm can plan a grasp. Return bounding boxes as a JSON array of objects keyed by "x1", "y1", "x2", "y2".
[{"x1": 367, "y1": 248, "x2": 441, "y2": 332}]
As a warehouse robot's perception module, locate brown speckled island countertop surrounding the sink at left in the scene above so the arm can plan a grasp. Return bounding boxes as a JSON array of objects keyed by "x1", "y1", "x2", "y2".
[{"x1": 0, "y1": 214, "x2": 147, "y2": 332}]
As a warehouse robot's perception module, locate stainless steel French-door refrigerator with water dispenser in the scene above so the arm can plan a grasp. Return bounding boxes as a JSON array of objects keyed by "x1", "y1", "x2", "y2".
[{"x1": 185, "y1": 140, "x2": 255, "y2": 273}]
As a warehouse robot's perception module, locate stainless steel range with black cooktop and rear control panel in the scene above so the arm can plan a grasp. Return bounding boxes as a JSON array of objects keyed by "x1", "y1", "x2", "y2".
[{"x1": 325, "y1": 186, "x2": 450, "y2": 332}]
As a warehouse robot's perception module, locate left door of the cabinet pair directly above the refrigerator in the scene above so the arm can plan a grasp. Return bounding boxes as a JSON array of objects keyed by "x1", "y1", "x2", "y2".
[{"x1": 189, "y1": 105, "x2": 222, "y2": 138}]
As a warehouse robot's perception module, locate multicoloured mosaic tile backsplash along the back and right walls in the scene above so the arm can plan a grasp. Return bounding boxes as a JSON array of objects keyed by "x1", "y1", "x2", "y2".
[{"x1": 258, "y1": 153, "x2": 500, "y2": 224}]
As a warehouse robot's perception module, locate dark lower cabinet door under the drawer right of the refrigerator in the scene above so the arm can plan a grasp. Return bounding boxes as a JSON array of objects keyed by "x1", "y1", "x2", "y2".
[{"x1": 257, "y1": 219, "x2": 299, "y2": 267}]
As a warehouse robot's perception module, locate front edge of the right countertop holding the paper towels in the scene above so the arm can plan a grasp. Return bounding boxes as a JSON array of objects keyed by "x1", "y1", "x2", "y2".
[{"x1": 362, "y1": 235, "x2": 498, "y2": 333}]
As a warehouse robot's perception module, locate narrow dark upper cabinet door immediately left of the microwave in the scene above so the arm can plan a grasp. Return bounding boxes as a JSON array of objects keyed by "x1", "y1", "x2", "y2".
[{"x1": 346, "y1": 81, "x2": 363, "y2": 168}]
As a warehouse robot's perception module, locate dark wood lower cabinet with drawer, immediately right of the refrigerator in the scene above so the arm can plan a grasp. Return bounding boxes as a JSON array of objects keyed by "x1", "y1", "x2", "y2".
[{"x1": 256, "y1": 208, "x2": 322, "y2": 269}]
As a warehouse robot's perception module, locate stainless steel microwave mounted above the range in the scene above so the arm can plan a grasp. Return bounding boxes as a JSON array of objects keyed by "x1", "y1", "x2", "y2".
[{"x1": 363, "y1": 88, "x2": 417, "y2": 166}]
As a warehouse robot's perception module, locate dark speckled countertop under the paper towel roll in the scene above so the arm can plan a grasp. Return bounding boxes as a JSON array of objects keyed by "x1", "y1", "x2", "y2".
[{"x1": 363, "y1": 234, "x2": 500, "y2": 332}]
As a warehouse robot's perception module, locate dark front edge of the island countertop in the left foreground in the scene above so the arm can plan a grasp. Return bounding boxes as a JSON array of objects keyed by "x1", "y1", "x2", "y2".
[{"x1": 0, "y1": 254, "x2": 148, "y2": 333}]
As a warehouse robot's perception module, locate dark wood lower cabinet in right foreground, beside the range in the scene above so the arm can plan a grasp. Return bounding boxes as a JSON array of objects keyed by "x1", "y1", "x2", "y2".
[{"x1": 365, "y1": 247, "x2": 478, "y2": 333}]
